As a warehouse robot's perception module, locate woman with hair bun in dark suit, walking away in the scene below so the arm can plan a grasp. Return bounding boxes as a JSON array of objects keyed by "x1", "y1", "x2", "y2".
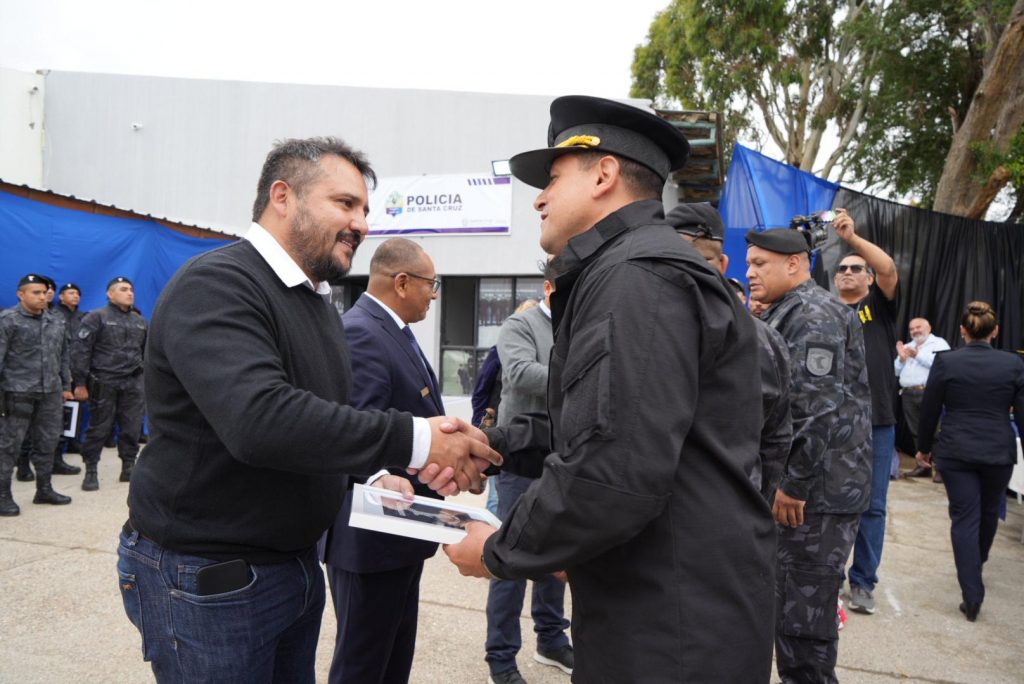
[{"x1": 916, "y1": 302, "x2": 1024, "y2": 623}]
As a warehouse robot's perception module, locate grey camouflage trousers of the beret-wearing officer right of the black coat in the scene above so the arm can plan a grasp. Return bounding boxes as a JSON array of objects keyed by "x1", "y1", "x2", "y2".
[{"x1": 775, "y1": 513, "x2": 860, "y2": 684}]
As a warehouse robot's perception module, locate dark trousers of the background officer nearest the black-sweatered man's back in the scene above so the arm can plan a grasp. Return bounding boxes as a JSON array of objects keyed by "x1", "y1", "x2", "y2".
[{"x1": 82, "y1": 376, "x2": 145, "y2": 465}]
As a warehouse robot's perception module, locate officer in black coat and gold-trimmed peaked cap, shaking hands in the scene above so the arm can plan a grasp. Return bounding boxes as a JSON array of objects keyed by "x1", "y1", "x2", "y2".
[{"x1": 445, "y1": 96, "x2": 775, "y2": 683}]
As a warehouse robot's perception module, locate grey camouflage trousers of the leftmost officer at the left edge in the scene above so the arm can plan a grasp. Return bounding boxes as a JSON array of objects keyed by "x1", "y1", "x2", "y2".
[{"x1": 0, "y1": 391, "x2": 63, "y2": 482}]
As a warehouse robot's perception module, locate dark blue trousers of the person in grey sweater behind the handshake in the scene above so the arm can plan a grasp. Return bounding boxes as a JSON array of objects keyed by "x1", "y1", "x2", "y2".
[{"x1": 485, "y1": 472, "x2": 569, "y2": 674}]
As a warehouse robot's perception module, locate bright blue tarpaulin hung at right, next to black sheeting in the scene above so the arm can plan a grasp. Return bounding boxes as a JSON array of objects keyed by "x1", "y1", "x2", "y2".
[{"x1": 718, "y1": 144, "x2": 840, "y2": 282}]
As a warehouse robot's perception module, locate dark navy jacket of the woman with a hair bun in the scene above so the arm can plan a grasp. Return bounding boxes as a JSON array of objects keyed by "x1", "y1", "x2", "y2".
[{"x1": 918, "y1": 342, "x2": 1024, "y2": 467}]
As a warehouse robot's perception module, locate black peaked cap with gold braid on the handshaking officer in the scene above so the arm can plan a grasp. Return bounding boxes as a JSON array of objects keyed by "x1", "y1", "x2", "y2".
[{"x1": 509, "y1": 95, "x2": 690, "y2": 188}]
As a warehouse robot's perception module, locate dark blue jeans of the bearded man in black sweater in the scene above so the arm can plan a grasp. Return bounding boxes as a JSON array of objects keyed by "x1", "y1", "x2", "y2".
[{"x1": 118, "y1": 531, "x2": 325, "y2": 684}]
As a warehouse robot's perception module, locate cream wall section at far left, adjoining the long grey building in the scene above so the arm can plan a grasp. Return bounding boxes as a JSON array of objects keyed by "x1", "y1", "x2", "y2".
[{"x1": 0, "y1": 68, "x2": 46, "y2": 187}]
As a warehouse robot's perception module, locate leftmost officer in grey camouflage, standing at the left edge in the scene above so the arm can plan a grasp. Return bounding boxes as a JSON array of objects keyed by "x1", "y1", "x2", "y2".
[{"x1": 0, "y1": 273, "x2": 71, "y2": 516}]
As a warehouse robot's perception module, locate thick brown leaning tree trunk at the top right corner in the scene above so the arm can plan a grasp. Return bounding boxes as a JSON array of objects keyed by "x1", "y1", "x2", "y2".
[{"x1": 932, "y1": 0, "x2": 1024, "y2": 218}]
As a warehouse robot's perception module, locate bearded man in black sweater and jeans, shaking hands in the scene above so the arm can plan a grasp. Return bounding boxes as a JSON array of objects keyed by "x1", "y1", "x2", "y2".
[{"x1": 118, "y1": 138, "x2": 501, "y2": 682}]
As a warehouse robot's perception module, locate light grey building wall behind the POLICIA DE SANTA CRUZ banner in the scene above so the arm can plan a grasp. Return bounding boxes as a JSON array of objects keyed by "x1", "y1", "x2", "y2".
[{"x1": 36, "y1": 72, "x2": 663, "y2": 370}]
